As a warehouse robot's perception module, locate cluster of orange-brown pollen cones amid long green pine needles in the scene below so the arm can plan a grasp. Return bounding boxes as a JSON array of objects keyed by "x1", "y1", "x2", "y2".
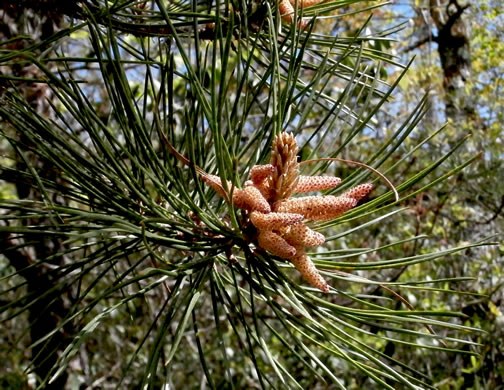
[{"x1": 202, "y1": 133, "x2": 373, "y2": 293}]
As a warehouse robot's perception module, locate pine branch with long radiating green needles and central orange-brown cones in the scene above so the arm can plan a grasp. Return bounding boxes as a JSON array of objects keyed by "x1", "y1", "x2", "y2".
[{"x1": 0, "y1": 0, "x2": 484, "y2": 389}]
